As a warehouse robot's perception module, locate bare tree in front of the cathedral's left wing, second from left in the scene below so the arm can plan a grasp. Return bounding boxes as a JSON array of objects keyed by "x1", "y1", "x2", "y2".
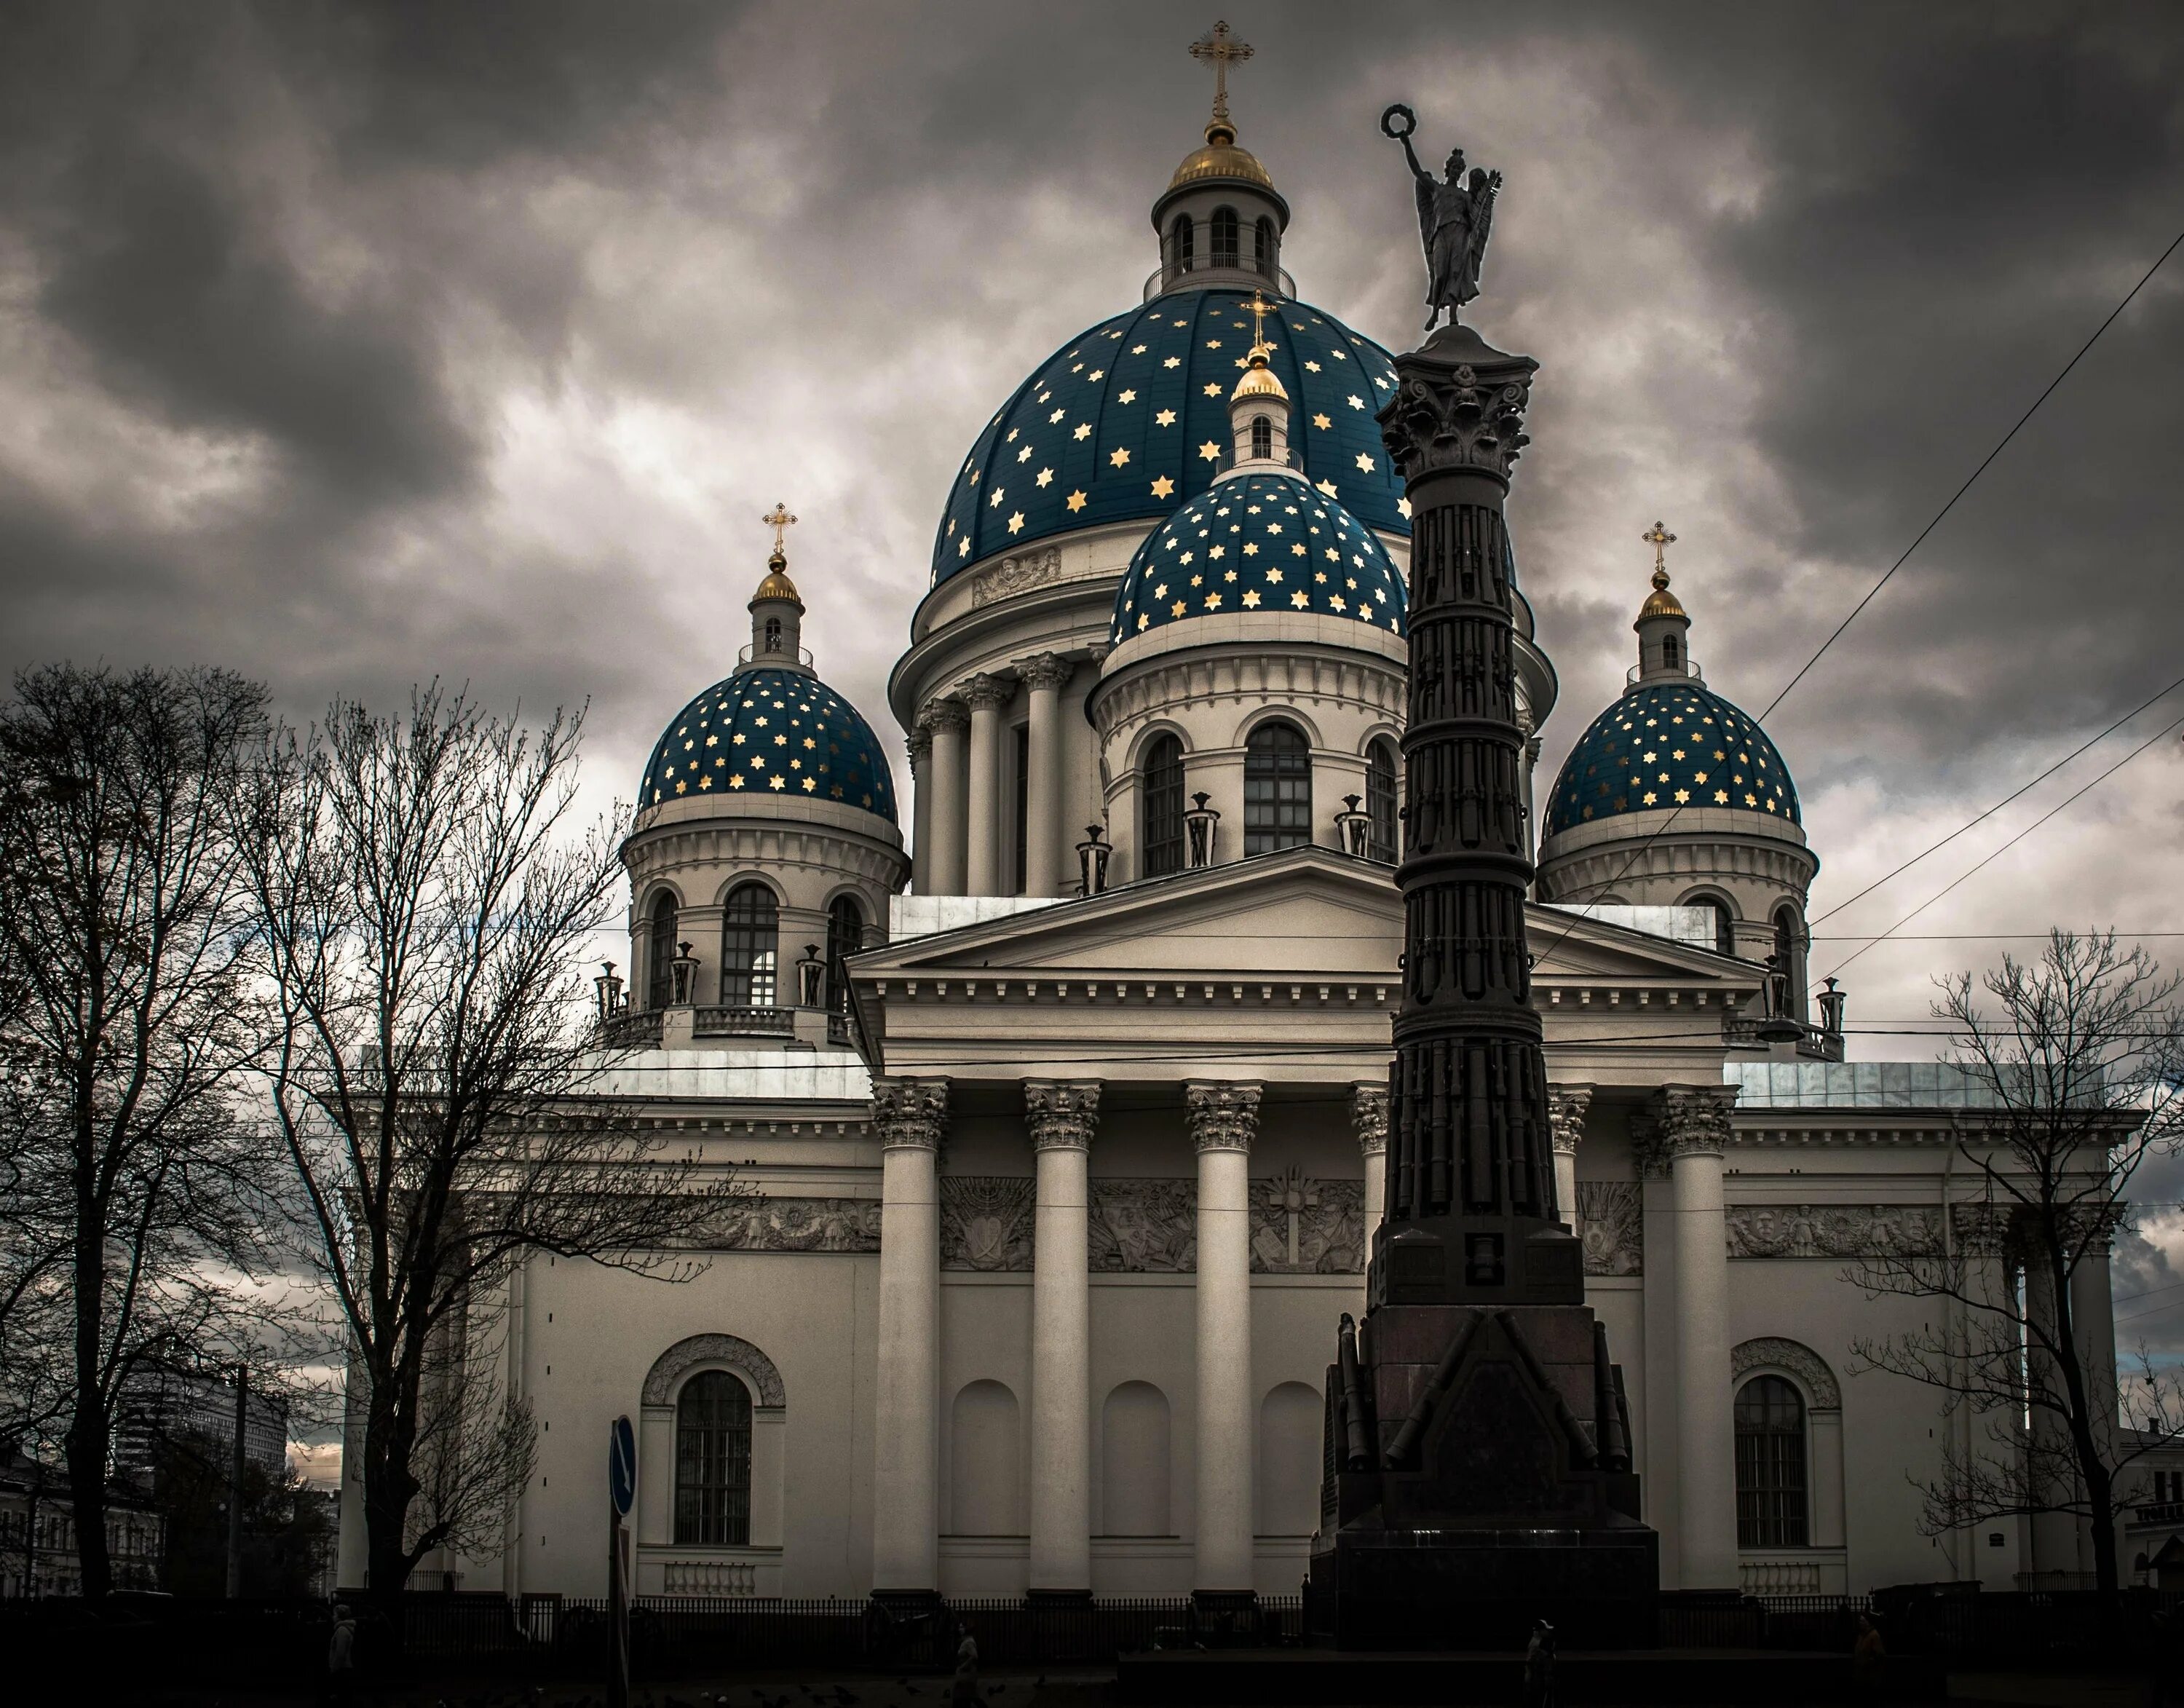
[{"x1": 256, "y1": 686, "x2": 719, "y2": 1625}]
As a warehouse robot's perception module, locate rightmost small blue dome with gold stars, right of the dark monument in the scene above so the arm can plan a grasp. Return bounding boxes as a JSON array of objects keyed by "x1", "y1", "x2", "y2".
[{"x1": 1546, "y1": 679, "x2": 1800, "y2": 837}]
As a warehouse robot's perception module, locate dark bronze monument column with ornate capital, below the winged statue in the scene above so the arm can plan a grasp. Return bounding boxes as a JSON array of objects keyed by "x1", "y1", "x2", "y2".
[{"x1": 1367, "y1": 325, "x2": 1586, "y2": 1306}]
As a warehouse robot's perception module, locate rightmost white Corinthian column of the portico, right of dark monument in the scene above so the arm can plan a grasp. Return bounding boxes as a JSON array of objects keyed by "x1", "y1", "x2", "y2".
[{"x1": 1653, "y1": 1086, "x2": 1736, "y2": 1590}]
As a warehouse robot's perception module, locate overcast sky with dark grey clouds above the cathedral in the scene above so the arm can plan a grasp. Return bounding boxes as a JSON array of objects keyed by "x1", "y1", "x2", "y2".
[{"x1": 0, "y1": 0, "x2": 2184, "y2": 1380}]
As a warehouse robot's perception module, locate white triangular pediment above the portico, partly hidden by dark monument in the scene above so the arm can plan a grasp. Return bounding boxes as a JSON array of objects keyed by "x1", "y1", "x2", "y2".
[{"x1": 852, "y1": 847, "x2": 1756, "y2": 987}]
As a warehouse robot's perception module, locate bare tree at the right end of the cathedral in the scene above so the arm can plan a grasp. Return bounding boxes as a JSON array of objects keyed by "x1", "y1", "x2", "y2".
[{"x1": 1852, "y1": 930, "x2": 2184, "y2": 1592}]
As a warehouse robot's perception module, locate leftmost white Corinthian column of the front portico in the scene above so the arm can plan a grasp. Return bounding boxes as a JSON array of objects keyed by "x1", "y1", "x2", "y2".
[{"x1": 871, "y1": 1079, "x2": 948, "y2": 1594}]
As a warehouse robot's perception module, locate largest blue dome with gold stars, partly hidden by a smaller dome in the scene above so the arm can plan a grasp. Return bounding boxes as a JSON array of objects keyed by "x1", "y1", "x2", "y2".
[{"x1": 933, "y1": 288, "x2": 1411, "y2": 585}]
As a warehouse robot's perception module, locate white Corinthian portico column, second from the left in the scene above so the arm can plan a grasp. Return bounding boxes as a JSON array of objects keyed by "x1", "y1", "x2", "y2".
[{"x1": 1024, "y1": 1079, "x2": 1099, "y2": 1594}]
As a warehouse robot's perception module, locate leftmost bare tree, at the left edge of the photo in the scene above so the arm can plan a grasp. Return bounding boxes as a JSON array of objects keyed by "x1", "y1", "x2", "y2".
[{"x1": 0, "y1": 664, "x2": 277, "y2": 1597}]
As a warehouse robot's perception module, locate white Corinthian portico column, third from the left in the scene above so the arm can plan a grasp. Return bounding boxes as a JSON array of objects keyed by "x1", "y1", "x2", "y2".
[{"x1": 1184, "y1": 1081, "x2": 1260, "y2": 1597}]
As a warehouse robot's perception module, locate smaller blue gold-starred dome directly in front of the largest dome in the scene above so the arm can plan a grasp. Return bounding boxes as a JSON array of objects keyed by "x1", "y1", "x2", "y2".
[{"x1": 1109, "y1": 474, "x2": 1406, "y2": 647}]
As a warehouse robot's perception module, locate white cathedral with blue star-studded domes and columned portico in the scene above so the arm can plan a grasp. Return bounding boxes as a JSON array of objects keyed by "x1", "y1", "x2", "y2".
[{"x1": 343, "y1": 87, "x2": 2112, "y2": 1597}]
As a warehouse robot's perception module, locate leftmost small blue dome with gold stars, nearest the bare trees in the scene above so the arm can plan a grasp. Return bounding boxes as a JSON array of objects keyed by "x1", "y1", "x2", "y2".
[{"x1": 638, "y1": 668, "x2": 895, "y2": 823}]
